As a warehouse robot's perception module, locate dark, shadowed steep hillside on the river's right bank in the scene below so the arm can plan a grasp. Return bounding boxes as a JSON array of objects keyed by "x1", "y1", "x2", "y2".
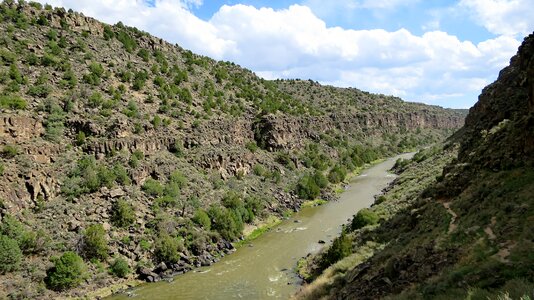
[{"x1": 296, "y1": 34, "x2": 534, "y2": 299}]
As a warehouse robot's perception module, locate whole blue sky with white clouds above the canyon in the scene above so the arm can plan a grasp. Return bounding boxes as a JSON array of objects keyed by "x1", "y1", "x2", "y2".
[{"x1": 38, "y1": 0, "x2": 534, "y2": 108}]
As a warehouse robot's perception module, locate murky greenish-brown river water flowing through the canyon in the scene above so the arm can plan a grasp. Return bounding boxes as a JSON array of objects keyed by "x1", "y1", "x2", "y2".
[{"x1": 109, "y1": 154, "x2": 412, "y2": 300}]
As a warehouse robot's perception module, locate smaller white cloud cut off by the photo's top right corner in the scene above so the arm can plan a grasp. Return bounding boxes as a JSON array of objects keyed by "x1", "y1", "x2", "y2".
[{"x1": 459, "y1": 0, "x2": 534, "y2": 36}]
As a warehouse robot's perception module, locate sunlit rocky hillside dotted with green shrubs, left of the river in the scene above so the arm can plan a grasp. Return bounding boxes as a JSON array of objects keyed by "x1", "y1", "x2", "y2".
[{"x1": 0, "y1": 1, "x2": 465, "y2": 298}]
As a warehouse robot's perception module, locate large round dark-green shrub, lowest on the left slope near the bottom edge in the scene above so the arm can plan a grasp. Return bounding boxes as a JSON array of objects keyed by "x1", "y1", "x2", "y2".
[{"x1": 45, "y1": 251, "x2": 86, "y2": 291}]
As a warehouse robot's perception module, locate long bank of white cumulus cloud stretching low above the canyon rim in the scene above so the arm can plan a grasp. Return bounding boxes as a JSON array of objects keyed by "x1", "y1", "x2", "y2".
[{"x1": 34, "y1": 0, "x2": 524, "y2": 107}]
